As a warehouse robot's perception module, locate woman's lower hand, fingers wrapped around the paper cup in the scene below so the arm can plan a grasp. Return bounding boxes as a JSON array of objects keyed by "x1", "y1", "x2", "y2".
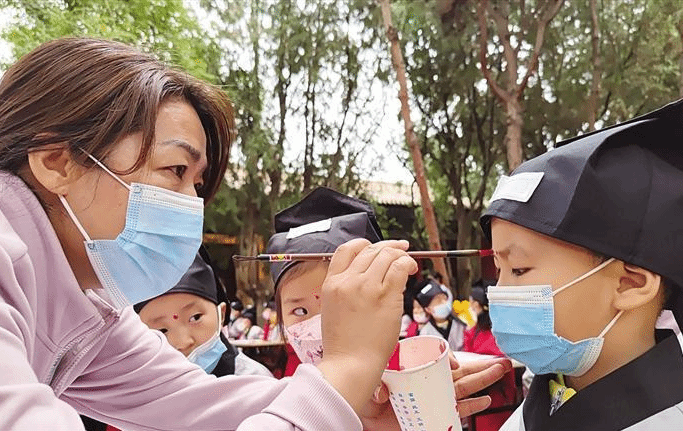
[{"x1": 361, "y1": 353, "x2": 512, "y2": 431}]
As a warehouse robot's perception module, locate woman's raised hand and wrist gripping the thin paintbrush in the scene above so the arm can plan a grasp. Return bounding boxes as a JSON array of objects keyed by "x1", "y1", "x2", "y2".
[{"x1": 318, "y1": 239, "x2": 417, "y2": 413}]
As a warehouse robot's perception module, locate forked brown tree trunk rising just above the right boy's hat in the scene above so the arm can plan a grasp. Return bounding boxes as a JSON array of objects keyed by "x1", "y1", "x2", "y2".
[{"x1": 477, "y1": 0, "x2": 564, "y2": 171}]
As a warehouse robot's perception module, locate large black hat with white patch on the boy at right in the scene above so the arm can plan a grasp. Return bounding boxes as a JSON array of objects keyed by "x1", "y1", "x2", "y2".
[{"x1": 481, "y1": 99, "x2": 683, "y2": 322}]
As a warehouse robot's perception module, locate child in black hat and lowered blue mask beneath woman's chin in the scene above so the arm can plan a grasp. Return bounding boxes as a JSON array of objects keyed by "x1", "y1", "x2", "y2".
[{"x1": 133, "y1": 254, "x2": 272, "y2": 377}]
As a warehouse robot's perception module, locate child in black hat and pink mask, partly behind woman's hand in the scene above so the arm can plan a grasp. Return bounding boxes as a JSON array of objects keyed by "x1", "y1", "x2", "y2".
[{"x1": 267, "y1": 187, "x2": 382, "y2": 364}]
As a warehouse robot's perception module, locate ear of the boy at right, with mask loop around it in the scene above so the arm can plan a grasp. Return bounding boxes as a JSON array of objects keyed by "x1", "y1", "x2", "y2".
[{"x1": 614, "y1": 263, "x2": 662, "y2": 310}]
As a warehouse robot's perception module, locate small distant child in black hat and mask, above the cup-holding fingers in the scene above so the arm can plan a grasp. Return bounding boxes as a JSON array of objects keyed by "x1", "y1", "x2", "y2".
[{"x1": 417, "y1": 280, "x2": 466, "y2": 351}]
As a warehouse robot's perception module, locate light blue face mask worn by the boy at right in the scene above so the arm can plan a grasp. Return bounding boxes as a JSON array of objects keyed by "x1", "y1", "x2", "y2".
[{"x1": 487, "y1": 258, "x2": 623, "y2": 376}]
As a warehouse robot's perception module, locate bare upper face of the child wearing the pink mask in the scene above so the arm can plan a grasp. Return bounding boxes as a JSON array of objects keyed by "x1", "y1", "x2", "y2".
[{"x1": 279, "y1": 264, "x2": 328, "y2": 328}]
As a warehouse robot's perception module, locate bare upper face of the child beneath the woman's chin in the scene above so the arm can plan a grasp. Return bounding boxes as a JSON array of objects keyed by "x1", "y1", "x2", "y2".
[{"x1": 140, "y1": 293, "x2": 226, "y2": 356}]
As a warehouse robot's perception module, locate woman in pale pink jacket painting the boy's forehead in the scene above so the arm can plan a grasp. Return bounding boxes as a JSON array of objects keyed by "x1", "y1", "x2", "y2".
[{"x1": 0, "y1": 38, "x2": 503, "y2": 430}]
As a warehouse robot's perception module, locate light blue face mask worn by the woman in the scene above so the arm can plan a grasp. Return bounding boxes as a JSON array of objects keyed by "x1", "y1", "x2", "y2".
[{"x1": 59, "y1": 154, "x2": 204, "y2": 309}]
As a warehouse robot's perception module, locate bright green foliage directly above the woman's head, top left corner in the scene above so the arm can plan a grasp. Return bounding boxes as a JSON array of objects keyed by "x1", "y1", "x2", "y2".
[{"x1": 0, "y1": 0, "x2": 216, "y2": 81}]
